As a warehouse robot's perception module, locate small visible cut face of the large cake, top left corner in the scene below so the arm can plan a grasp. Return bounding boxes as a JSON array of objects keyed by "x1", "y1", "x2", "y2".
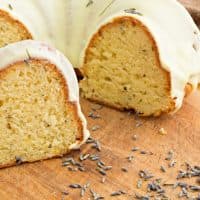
[{"x1": 0, "y1": 10, "x2": 32, "y2": 47}]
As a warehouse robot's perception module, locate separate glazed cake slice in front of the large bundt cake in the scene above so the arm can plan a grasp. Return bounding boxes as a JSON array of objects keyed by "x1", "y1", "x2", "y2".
[{"x1": 0, "y1": 41, "x2": 89, "y2": 168}]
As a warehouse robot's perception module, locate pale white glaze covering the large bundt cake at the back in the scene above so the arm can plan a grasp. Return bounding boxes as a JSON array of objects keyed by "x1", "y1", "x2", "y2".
[{"x1": 0, "y1": 0, "x2": 200, "y2": 110}]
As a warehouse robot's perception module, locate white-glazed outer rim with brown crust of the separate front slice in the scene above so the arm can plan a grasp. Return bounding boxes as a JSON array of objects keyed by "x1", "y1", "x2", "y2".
[{"x1": 0, "y1": 40, "x2": 90, "y2": 168}]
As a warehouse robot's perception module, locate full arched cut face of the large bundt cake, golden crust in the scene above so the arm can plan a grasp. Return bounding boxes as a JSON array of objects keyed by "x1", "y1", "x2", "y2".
[{"x1": 80, "y1": 17, "x2": 173, "y2": 116}]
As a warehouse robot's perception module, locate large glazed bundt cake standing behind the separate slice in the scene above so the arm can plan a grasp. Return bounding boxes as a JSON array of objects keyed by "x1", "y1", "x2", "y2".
[{"x1": 0, "y1": 0, "x2": 200, "y2": 116}]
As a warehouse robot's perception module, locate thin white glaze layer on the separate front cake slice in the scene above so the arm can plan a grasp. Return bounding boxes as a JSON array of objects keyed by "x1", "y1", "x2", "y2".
[{"x1": 0, "y1": 40, "x2": 89, "y2": 149}]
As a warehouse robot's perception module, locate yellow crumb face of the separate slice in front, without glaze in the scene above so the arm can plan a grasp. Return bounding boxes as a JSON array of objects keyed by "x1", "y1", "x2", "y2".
[{"x1": 0, "y1": 59, "x2": 82, "y2": 166}]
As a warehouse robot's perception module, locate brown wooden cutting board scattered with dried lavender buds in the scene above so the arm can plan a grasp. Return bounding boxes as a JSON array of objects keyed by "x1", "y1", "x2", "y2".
[{"x1": 0, "y1": 0, "x2": 200, "y2": 200}]
